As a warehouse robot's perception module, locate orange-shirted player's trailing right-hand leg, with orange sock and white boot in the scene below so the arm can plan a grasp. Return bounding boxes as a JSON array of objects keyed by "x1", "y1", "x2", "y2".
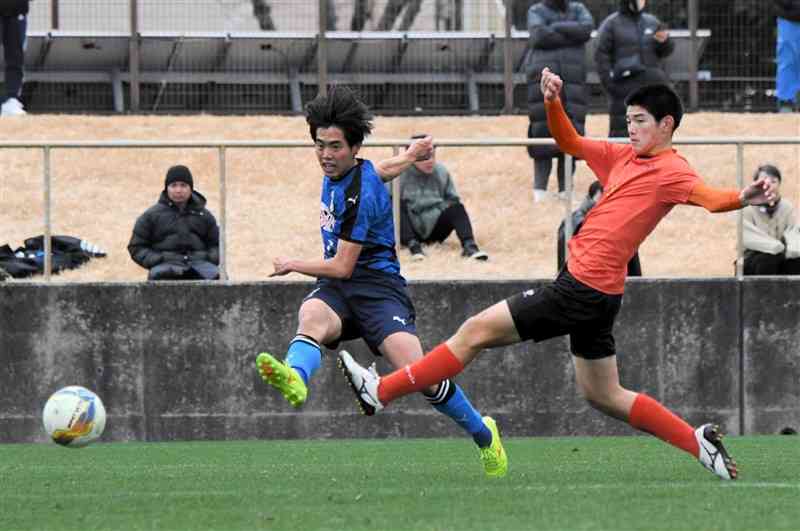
[{"x1": 573, "y1": 356, "x2": 738, "y2": 479}]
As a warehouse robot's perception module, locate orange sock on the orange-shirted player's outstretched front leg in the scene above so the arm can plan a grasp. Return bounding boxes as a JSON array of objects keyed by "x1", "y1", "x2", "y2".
[{"x1": 378, "y1": 343, "x2": 464, "y2": 404}]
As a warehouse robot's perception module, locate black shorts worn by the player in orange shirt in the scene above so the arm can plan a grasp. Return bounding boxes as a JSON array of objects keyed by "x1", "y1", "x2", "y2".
[{"x1": 507, "y1": 267, "x2": 622, "y2": 359}]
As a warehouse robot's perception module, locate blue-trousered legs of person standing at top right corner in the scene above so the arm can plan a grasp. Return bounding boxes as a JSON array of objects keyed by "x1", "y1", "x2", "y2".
[{"x1": 773, "y1": 0, "x2": 800, "y2": 112}]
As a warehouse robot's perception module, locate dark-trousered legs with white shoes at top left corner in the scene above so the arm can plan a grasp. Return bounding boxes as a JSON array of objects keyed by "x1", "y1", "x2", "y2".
[{"x1": 0, "y1": 0, "x2": 29, "y2": 116}]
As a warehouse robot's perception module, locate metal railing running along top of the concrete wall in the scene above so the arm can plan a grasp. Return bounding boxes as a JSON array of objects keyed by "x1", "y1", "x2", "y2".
[{"x1": 0, "y1": 137, "x2": 800, "y2": 281}]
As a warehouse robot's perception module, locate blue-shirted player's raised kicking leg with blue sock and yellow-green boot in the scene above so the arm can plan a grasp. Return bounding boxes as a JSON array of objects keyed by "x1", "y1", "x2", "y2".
[{"x1": 256, "y1": 298, "x2": 341, "y2": 407}]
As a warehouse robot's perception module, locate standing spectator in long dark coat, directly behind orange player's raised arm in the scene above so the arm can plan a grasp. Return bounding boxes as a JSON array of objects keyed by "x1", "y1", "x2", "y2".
[{"x1": 527, "y1": 0, "x2": 594, "y2": 201}]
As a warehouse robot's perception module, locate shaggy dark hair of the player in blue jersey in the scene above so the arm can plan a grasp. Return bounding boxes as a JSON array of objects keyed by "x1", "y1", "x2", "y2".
[{"x1": 306, "y1": 85, "x2": 374, "y2": 147}]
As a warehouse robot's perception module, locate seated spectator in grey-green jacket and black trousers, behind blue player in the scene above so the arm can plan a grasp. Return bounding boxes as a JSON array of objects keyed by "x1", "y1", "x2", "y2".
[{"x1": 400, "y1": 135, "x2": 489, "y2": 261}]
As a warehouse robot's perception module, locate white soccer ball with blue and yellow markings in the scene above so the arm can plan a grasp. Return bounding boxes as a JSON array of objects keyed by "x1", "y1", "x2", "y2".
[{"x1": 42, "y1": 385, "x2": 106, "y2": 448}]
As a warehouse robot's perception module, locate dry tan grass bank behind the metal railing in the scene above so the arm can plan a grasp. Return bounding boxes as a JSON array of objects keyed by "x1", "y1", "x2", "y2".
[{"x1": 0, "y1": 113, "x2": 800, "y2": 282}]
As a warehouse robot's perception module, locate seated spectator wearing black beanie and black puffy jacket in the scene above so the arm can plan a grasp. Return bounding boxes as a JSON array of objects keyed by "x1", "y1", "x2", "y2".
[{"x1": 128, "y1": 166, "x2": 219, "y2": 280}]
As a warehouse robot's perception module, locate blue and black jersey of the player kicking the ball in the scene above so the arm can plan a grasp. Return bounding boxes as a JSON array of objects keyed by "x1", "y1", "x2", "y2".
[{"x1": 319, "y1": 159, "x2": 400, "y2": 275}]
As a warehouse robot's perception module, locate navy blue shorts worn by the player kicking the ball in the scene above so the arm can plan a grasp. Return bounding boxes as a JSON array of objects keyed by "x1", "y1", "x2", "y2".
[{"x1": 303, "y1": 268, "x2": 417, "y2": 356}]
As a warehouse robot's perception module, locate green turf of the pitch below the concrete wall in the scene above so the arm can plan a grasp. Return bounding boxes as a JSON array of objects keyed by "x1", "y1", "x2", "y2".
[{"x1": 0, "y1": 436, "x2": 800, "y2": 531}]
